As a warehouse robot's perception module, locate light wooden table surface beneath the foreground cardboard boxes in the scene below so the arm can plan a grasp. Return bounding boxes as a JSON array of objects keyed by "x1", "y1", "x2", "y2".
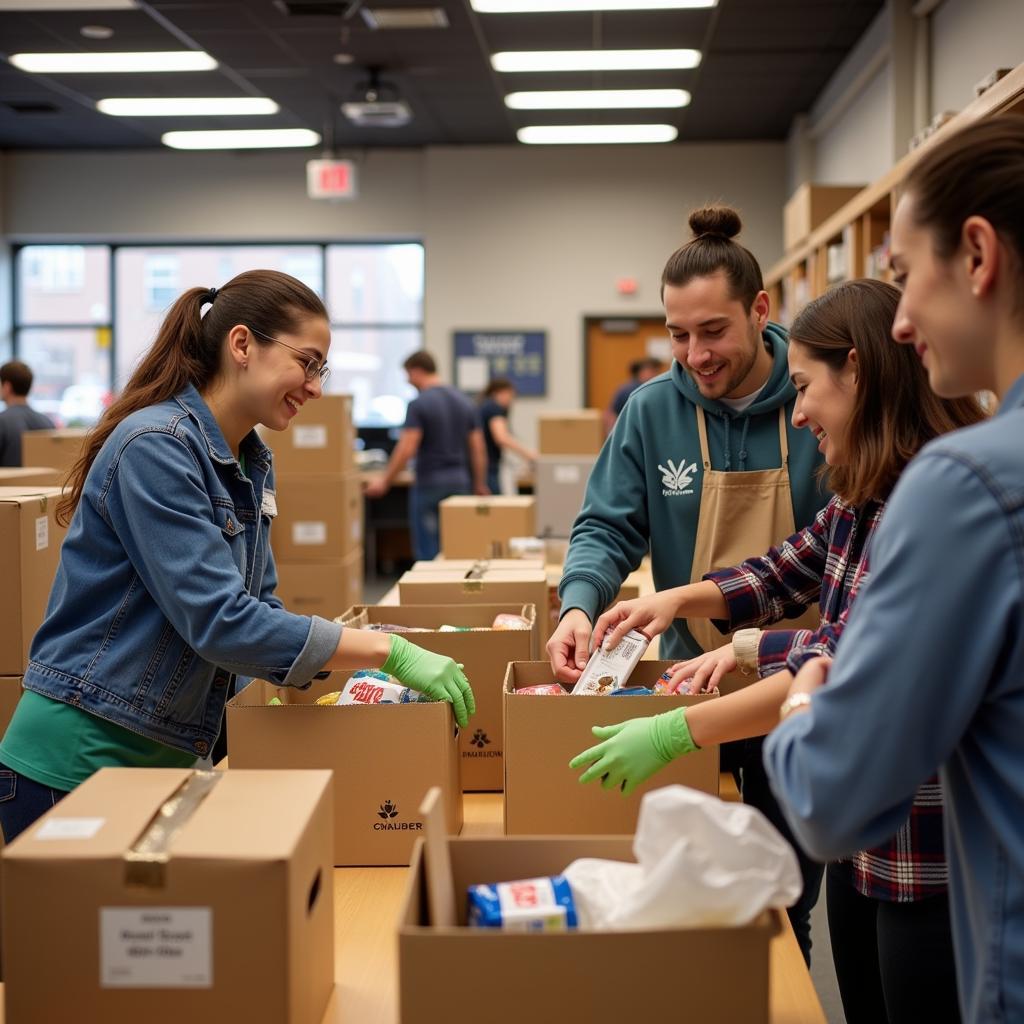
[{"x1": 324, "y1": 775, "x2": 825, "y2": 1024}]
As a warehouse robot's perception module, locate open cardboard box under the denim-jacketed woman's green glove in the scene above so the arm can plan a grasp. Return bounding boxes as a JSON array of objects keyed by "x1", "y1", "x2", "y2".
[{"x1": 227, "y1": 672, "x2": 462, "y2": 864}]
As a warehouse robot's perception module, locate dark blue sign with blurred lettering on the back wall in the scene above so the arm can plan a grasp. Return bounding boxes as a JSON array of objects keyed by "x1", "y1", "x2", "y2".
[{"x1": 452, "y1": 331, "x2": 548, "y2": 397}]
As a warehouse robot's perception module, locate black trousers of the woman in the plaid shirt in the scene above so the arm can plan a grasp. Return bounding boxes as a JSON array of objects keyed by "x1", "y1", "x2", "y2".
[{"x1": 825, "y1": 866, "x2": 961, "y2": 1024}]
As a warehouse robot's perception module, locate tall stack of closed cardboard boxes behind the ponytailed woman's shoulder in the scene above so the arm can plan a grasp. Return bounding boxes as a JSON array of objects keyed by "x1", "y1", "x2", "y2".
[{"x1": 263, "y1": 394, "x2": 364, "y2": 618}]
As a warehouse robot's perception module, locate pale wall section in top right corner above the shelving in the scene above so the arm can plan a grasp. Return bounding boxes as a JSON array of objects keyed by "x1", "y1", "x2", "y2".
[{"x1": 930, "y1": 0, "x2": 1024, "y2": 115}]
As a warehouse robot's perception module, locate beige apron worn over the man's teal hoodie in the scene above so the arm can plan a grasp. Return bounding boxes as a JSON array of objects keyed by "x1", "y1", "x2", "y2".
[{"x1": 686, "y1": 406, "x2": 821, "y2": 693}]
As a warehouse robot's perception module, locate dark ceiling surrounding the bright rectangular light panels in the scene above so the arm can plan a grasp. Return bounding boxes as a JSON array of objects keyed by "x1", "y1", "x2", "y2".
[{"x1": 0, "y1": 0, "x2": 883, "y2": 150}]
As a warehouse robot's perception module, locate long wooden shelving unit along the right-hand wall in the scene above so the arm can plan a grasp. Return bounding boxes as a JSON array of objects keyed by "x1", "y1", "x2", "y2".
[{"x1": 765, "y1": 63, "x2": 1024, "y2": 324}]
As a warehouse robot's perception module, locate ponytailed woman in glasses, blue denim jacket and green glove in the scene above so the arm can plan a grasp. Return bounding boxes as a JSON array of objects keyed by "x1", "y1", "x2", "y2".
[{"x1": 0, "y1": 270, "x2": 475, "y2": 842}]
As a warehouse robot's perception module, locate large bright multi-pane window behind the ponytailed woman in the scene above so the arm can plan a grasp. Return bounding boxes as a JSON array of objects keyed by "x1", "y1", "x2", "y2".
[{"x1": 13, "y1": 243, "x2": 424, "y2": 426}]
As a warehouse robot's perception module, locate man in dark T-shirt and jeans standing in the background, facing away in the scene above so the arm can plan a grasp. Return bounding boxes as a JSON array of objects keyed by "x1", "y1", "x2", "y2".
[{"x1": 366, "y1": 351, "x2": 490, "y2": 559}]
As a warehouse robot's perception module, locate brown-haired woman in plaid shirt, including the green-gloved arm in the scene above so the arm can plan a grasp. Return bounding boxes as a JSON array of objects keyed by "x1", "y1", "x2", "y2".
[{"x1": 571, "y1": 281, "x2": 983, "y2": 1024}]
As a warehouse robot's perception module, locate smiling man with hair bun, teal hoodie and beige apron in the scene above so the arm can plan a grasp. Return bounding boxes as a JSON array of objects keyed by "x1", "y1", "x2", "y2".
[{"x1": 548, "y1": 206, "x2": 827, "y2": 959}]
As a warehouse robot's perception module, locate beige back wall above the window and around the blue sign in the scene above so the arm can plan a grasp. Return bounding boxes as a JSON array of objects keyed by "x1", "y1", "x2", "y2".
[{"x1": 0, "y1": 143, "x2": 785, "y2": 443}]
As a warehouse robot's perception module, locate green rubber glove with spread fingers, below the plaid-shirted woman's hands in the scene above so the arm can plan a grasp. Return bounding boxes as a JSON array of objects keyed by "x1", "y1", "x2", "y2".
[{"x1": 569, "y1": 708, "x2": 699, "y2": 795}]
